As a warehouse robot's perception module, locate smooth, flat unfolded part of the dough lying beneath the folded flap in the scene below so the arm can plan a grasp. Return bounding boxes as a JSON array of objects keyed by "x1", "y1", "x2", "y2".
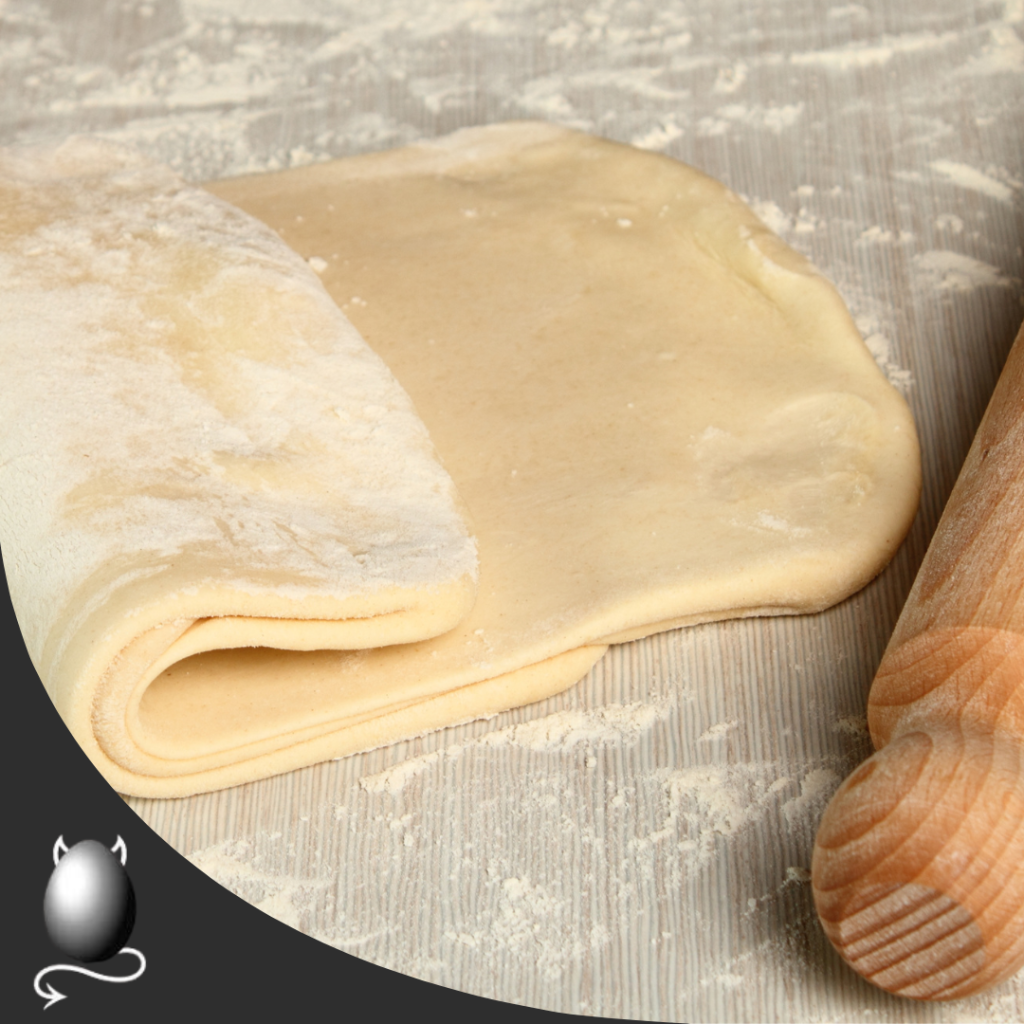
[{"x1": 4, "y1": 117, "x2": 920, "y2": 796}]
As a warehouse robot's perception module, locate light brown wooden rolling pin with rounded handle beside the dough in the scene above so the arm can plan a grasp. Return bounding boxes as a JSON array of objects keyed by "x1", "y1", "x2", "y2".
[{"x1": 811, "y1": 328, "x2": 1024, "y2": 999}]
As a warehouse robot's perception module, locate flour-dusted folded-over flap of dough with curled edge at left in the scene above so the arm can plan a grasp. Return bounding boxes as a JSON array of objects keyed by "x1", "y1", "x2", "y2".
[{"x1": 0, "y1": 139, "x2": 476, "y2": 794}]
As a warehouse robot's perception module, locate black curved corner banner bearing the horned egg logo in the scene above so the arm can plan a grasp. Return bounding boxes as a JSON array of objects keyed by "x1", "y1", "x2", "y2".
[{"x1": 0, "y1": 552, "x2": 569, "y2": 1024}]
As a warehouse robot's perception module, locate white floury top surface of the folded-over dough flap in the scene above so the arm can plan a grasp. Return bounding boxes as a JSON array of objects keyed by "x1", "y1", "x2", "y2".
[{"x1": 0, "y1": 138, "x2": 475, "y2": 679}]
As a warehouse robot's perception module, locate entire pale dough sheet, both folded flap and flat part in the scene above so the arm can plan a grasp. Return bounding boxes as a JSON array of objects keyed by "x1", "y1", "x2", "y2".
[{"x1": 2, "y1": 124, "x2": 920, "y2": 796}]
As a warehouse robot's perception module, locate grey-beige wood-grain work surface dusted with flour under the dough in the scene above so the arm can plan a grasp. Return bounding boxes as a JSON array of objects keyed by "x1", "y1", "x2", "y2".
[{"x1": 0, "y1": 0, "x2": 1024, "y2": 1021}]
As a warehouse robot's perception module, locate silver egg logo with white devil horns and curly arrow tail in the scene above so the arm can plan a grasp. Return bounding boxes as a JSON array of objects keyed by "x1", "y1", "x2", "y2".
[{"x1": 35, "y1": 836, "x2": 145, "y2": 1010}]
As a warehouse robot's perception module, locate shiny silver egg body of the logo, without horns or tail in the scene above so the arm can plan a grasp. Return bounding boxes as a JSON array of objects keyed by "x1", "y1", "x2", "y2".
[{"x1": 43, "y1": 839, "x2": 135, "y2": 964}]
